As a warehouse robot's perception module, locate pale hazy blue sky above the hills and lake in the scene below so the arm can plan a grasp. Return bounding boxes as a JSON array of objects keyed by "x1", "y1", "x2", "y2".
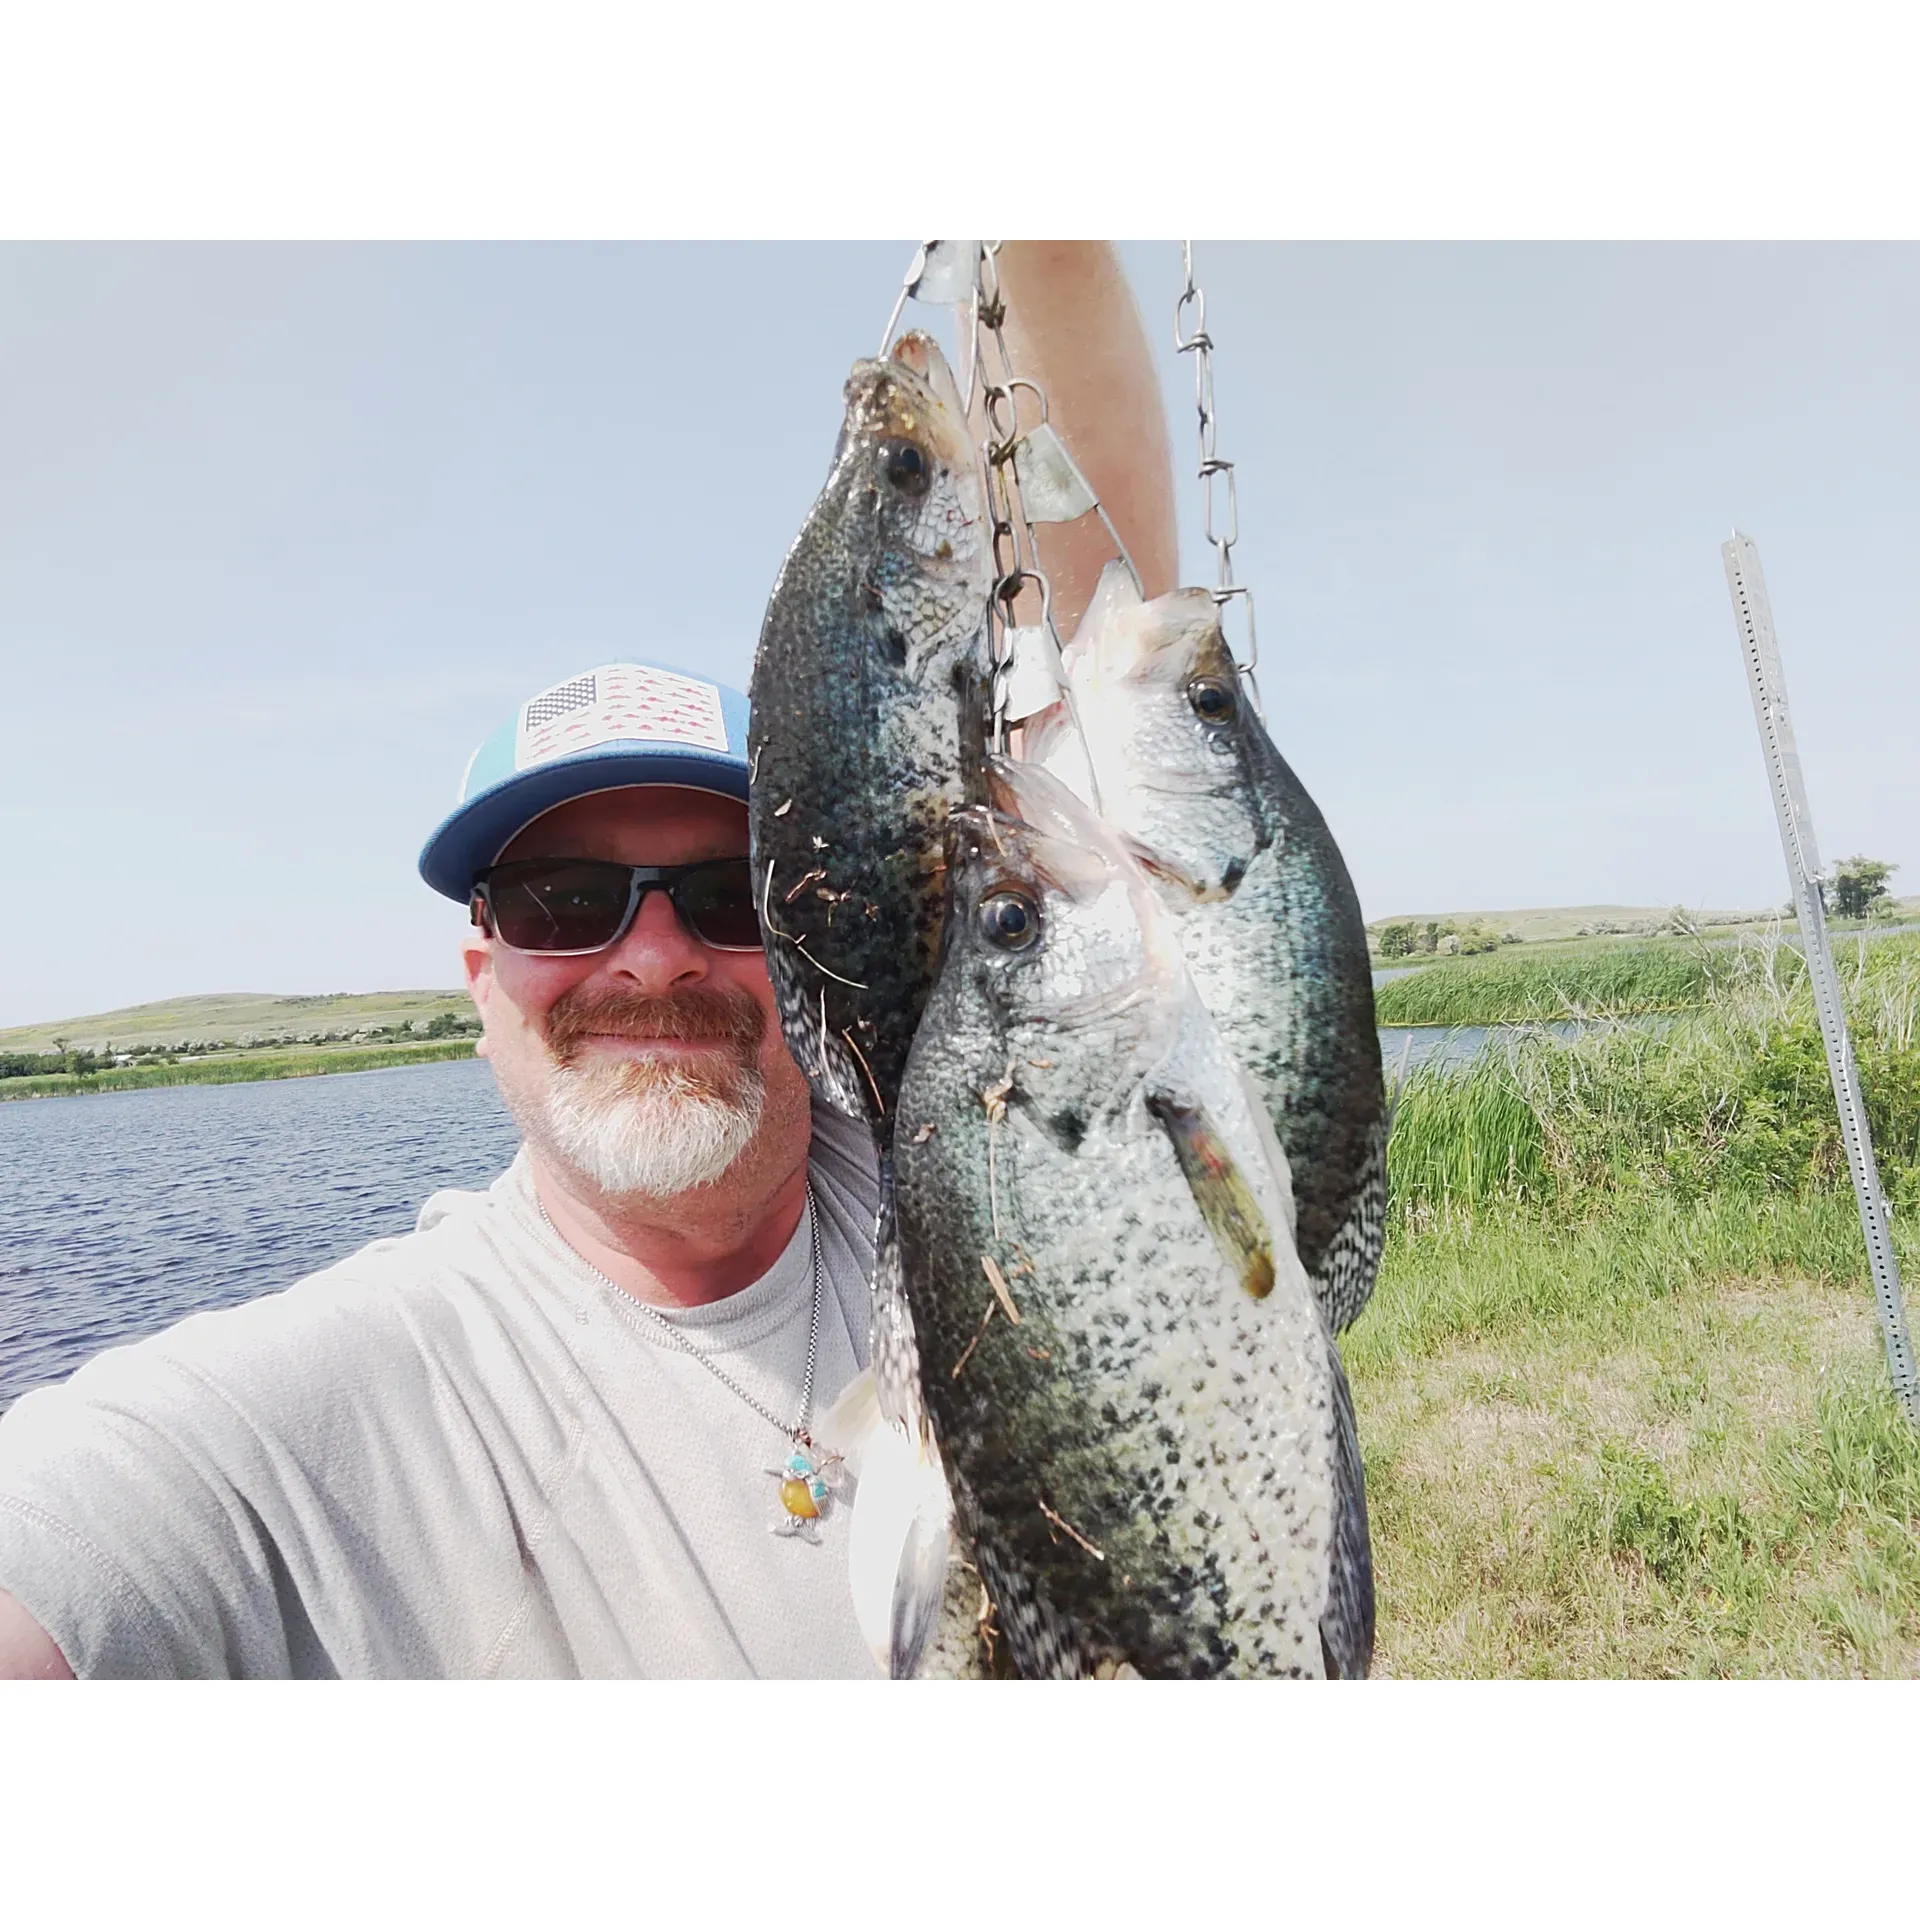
[{"x1": 0, "y1": 242, "x2": 1920, "y2": 1025}]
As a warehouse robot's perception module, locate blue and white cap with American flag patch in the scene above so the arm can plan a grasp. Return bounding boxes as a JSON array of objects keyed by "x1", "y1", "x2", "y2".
[{"x1": 420, "y1": 660, "x2": 747, "y2": 902}]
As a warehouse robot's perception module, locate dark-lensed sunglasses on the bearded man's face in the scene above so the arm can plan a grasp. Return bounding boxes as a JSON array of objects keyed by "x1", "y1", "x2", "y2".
[{"x1": 470, "y1": 860, "x2": 760, "y2": 954}]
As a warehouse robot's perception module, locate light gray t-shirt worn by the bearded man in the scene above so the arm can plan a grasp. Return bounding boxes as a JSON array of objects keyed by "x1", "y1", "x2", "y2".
[{"x1": 0, "y1": 1110, "x2": 877, "y2": 1678}]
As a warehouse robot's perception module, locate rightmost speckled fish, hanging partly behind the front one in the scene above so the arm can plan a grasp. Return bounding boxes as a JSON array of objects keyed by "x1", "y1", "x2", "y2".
[{"x1": 1027, "y1": 563, "x2": 1388, "y2": 1329}]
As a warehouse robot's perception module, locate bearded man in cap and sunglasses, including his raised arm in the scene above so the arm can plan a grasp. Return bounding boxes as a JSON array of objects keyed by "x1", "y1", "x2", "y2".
[{"x1": 0, "y1": 244, "x2": 1173, "y2": 1676}]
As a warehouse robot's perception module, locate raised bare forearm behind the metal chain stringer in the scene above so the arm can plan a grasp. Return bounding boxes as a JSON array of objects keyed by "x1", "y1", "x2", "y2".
[{"x1": 989, "y1": 240, "x2": 1181, "y2": 639}]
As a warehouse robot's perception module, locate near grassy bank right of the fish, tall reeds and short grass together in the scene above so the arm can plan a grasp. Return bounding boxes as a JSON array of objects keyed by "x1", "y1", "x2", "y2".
[{"x1": 1346, "y1": 941, "x2": 1920, "y2": 1676}]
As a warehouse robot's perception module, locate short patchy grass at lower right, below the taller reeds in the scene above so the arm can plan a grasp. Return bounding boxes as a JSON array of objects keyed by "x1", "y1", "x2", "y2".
[{"x1": 1348, "y1": 1196, "x2": 1920, "y2": 1676}]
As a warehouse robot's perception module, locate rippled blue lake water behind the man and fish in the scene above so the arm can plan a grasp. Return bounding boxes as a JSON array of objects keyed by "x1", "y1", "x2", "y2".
[{"x1": 0, "y1": 1027, "x2": 1512, "y2": 1411}]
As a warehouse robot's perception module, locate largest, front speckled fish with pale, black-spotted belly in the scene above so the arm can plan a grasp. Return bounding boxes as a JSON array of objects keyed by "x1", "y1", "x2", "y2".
[{"x1": 897, "y1": 760, "x2": 1373, "y2": 1678}]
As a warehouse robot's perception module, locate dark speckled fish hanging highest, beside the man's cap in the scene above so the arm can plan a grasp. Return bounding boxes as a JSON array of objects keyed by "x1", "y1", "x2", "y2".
[{"x1": 747, "y1": 332, "x2": 991, "y2": 1142}]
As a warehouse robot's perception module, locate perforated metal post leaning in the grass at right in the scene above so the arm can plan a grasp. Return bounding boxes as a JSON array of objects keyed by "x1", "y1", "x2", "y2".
[{"x1": 1720, "y1": 530, "x2": 1920, "y2": 1423}]
